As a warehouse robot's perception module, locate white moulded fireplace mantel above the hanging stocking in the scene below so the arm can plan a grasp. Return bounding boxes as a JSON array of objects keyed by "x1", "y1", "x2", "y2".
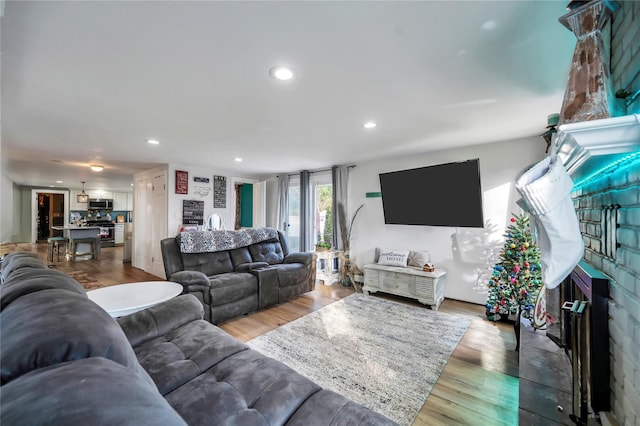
[{"x1": 555, "y1": 114, "x2": 640, "y2": 174}]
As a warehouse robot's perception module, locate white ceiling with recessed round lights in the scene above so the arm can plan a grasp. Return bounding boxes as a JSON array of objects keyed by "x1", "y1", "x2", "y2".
[{"x1": 1, "y1": 1, "x2": 575, "y2": 190}]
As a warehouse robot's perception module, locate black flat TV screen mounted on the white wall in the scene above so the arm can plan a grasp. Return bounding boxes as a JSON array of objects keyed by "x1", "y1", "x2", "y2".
[{"x1": 380, "y1": 159, "x2": 484, "y2": 228}]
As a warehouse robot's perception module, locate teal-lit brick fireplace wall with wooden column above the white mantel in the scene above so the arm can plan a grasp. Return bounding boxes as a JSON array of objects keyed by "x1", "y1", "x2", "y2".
[{"x1": 560, "y1": 0, "x2": 640, "y2": 425}]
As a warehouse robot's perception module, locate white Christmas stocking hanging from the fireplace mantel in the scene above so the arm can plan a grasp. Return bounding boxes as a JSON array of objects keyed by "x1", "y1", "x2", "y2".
[{"x1": 516, "y1": 155, "x2": 584, "y2": 288}]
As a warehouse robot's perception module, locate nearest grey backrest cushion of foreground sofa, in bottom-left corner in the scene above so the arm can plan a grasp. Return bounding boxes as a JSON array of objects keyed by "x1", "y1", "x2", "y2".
[{"x1": 0, "y1": 358, "x2": 186, "y2": 426}]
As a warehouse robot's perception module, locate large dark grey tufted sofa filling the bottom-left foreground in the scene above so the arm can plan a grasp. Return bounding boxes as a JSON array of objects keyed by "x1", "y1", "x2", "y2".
[{"x1": 0, "y1": 252, "x2": 394, "y2": 426}]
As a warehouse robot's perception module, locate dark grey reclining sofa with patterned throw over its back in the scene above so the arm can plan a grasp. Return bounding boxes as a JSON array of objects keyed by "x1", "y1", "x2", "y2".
[{"x1": 160, "y1": 228, "x2": 316, "y2": 324}]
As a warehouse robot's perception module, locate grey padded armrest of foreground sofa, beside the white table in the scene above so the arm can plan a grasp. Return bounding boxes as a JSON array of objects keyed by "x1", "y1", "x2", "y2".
[{"x1": 117, "y1": 294, "x2": 204, "y2": 347}]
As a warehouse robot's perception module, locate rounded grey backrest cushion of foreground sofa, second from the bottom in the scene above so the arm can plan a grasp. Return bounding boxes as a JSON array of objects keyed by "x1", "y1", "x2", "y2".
[{"x1": 0, "y1": 289, "x2": 151, "y2": 384}]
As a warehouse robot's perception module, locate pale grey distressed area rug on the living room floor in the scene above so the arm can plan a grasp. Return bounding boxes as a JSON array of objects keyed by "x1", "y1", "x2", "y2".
[{"x1": 247, "y1": 294, "x2": 470, "y2": 425}]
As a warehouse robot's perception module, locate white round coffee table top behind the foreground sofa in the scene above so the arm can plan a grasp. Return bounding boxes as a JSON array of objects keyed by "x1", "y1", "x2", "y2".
[{"x1": 87, "y1": 281, "x2": 182, "y2": 318}]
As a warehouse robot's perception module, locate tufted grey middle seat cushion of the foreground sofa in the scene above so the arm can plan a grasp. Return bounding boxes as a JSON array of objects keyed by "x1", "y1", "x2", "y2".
[{"x1": 165, "y1": 350, "x2": 322, "y2": 425}]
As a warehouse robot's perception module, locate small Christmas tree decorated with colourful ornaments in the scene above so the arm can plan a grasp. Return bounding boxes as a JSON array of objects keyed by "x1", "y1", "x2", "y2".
[{"x1": 486, "y1": 214, "x2": 542, "y2": 321}]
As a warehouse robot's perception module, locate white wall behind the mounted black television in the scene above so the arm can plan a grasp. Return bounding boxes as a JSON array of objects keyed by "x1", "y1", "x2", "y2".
[{"x1": 349, "y1": 137, "x2": 545, "y2": 304}]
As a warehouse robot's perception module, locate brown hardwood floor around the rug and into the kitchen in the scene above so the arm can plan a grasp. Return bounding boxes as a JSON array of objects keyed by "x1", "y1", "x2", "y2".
[{"x1": 0, "y1": 243, "x2": 519, "y2": 426}]
